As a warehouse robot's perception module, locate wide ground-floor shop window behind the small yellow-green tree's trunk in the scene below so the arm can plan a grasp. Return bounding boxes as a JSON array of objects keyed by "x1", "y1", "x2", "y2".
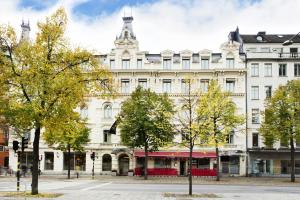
[{"x1": 63, "y1": 152, "x2": 86, "y2": 171}]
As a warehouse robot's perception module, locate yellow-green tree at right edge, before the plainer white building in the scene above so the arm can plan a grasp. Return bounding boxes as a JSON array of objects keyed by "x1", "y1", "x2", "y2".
[{"x1": 260, "y1": 80, "x2": 300, "y2": 182}]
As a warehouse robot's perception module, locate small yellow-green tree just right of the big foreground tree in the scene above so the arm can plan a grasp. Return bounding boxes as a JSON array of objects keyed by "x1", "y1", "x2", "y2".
[{"x1": 43, "y1": 111, "x2": 90, "y2": 179}]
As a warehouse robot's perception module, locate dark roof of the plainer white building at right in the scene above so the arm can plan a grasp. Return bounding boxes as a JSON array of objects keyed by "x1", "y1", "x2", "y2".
[{"x1": 240, "y1": 32, "x2": 300, "y2": 43}]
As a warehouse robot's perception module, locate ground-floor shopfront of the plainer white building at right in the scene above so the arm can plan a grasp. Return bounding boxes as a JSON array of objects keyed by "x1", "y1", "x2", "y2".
[{"x1": 249, "y1": 149, "x2": 300, "y2": 176}]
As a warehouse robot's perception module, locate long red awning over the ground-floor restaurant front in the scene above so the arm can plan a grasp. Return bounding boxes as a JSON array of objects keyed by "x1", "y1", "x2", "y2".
[{"x1": 134, "y1": 151, "x2": 216, "y2": 158}]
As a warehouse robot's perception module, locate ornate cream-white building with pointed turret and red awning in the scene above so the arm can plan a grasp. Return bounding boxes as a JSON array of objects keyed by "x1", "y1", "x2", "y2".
[{"x1": 10, "y1": 17, "x2": 247, "y2": 175}]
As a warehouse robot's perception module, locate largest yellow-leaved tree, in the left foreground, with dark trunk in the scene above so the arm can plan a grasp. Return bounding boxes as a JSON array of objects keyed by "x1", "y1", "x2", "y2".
[{"x1": 0, "y1": 9, "x2": 111, "y2": 195}]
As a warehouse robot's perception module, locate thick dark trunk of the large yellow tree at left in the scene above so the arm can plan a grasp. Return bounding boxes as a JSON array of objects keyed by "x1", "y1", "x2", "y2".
[{"x1": 31, "y1": 124, "x2": 41, "y2": 195}]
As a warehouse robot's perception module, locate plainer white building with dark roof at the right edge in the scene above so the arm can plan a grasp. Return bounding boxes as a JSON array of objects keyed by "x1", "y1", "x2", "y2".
[{"x1": 229, "y1": 29, "x2": 300, "y2": 175}]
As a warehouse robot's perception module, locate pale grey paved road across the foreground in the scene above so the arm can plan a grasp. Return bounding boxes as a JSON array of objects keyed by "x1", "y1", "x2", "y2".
[{"x1": 0, "y1": 179, "x2": 300, "y2": 200}]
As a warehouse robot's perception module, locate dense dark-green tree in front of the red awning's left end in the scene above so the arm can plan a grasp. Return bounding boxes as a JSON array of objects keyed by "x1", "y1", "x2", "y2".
[{"x1": 119, "y1": 86, "x2": 174, "y2": 180}]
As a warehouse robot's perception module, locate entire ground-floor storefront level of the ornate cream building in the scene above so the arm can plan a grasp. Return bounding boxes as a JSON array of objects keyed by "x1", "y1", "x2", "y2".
[{"x1": 9, "y1": 148, "x2": 245, "y2": 176}]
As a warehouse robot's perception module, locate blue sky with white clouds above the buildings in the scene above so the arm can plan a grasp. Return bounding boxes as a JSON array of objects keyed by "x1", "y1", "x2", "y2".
[{"x1": 0, "y1": 0, "x2": 300, "y2": 53}]
